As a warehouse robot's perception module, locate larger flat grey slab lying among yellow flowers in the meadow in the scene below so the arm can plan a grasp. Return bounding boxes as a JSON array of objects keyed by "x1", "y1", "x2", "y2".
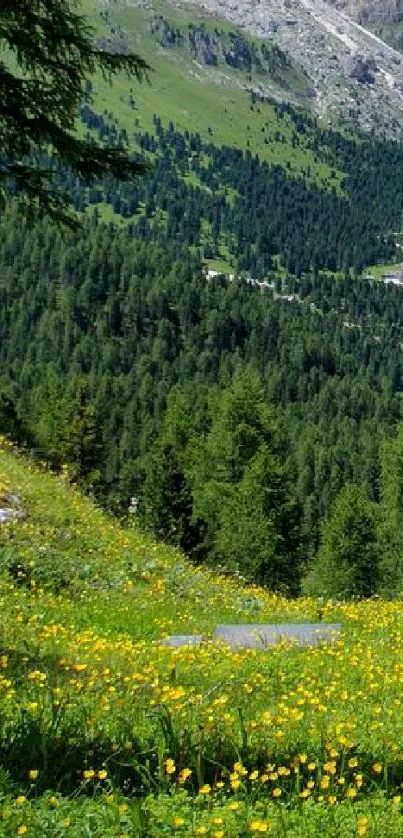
[{"x1": 213, "y1": 623, "x2": 342, "y2": 649}]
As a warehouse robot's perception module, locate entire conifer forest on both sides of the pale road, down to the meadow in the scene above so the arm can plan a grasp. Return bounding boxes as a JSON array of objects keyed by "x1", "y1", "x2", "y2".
[{"x1": 0, "y1": 0, "x2": 403, "y2": 596}]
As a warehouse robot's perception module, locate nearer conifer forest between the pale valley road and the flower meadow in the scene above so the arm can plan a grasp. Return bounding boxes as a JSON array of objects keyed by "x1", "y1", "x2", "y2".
[{"x1": 0, "y1": 199, "x2": 403, "y2": 590}]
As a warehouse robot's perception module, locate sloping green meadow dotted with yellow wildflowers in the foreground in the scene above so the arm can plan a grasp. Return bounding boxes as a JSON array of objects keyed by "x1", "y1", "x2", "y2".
[{"x1": 0, "y1": 444, "x2": 403, "y2": 838}]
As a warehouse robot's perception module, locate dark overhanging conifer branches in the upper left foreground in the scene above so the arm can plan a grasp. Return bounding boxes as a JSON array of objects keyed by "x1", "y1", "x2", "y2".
[{"x1": 0, "y1": 0, "x2": 149, "y2": 217}]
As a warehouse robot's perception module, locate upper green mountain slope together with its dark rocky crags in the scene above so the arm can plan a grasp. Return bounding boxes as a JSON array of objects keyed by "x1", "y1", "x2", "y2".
[{"x1": 79, "y1": 0, "x2": 340, "y2": 184}]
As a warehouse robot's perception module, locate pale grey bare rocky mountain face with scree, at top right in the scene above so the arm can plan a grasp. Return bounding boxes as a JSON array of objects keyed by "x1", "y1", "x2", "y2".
[{"x1": 160, "y1": 0, "x2": 403, "y2": 136}]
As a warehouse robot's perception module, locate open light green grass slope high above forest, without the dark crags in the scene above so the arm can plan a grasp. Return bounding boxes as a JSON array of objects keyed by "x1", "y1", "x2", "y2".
[{"x1": 83, "y1": 0, "x2": 341, "y2": 187}]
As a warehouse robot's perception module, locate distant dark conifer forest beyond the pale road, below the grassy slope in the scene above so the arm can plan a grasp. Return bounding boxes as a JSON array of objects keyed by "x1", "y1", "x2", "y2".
[{"x1": 76, "y1": 106, "x2": 403, "y2": 279}]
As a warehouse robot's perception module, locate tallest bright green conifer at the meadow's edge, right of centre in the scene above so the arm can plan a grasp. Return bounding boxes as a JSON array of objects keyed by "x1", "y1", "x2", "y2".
[{"x1": 192, "y1": 368, "x2": 301, "y2": 592}]
